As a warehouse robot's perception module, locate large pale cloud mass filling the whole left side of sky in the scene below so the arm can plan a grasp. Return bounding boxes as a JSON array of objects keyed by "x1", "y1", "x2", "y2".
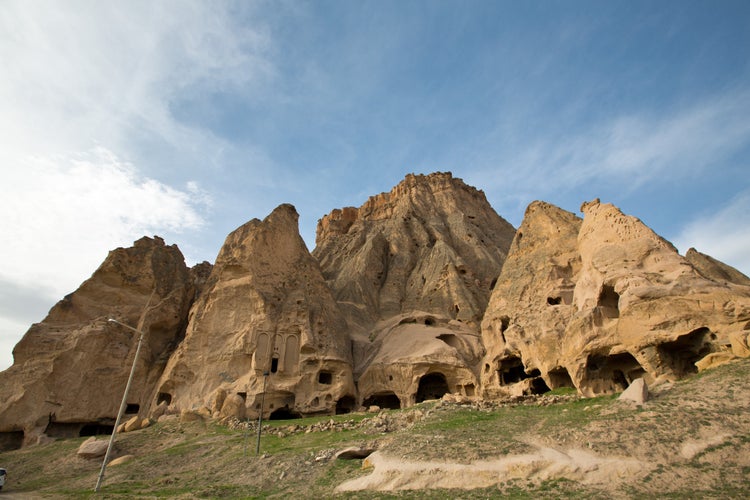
[{"x1": 0, "y1": 0, "x2": 274, "y2": 368}]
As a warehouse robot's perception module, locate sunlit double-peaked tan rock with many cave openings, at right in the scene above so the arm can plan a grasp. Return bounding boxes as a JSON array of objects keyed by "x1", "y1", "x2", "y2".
[{"x1": 482, "y1": 200, "x2": 750, "y2": 397}]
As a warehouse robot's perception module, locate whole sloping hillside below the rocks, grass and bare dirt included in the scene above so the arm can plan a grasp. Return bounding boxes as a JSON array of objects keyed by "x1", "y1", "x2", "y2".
[{"x1": 0, "y1": 359, "x2": 750, "y2": 498}]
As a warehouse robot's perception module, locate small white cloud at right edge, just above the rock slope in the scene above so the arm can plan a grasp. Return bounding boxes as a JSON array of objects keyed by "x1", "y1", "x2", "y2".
[{"x1": 673, "y1": 190, "x2": 750, "y2": 275}]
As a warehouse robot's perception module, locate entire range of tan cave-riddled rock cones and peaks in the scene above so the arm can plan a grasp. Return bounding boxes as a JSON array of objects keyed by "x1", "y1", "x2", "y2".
[{"x1": 0, "y1": 173, "x2": 750, "y2": 449}]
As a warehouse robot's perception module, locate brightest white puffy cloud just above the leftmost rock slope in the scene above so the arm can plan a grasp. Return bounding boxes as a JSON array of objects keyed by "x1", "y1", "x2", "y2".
[{"x1": 0, "y1": 148, "x2": 209, "y2": 299}]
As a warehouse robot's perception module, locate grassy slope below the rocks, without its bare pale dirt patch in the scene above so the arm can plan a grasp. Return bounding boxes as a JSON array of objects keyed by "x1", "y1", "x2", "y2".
[{"x1": 0, "y1": 360, "x2": 750, "y2": 498}]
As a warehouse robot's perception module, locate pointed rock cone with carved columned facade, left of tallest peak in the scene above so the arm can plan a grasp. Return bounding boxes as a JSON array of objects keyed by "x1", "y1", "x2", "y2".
[{"x1": 155, "y1": 205, "x2": 356, "y2": 418}]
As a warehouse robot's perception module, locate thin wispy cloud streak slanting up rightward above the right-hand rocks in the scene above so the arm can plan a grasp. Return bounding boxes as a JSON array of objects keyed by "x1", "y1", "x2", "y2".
[{"x1": 473, "y1": 90, "x2": 750, "y2": 200}]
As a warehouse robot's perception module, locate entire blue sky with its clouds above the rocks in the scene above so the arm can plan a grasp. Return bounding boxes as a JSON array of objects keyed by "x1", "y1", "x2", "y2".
[{"x1": 0, "y1": 0, "x2": 750, "y2": 369}]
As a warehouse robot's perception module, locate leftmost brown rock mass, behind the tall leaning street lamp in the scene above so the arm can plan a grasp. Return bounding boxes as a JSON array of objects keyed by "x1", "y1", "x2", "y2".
[{"x1": 0, "y1": 237, "x2": 195, "y2": 444}]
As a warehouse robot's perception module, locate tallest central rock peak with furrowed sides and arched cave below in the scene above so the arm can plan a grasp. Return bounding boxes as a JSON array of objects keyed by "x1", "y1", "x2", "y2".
[{"x1": 313, "y1": 173, "x2": 515, "y2": 407}]
